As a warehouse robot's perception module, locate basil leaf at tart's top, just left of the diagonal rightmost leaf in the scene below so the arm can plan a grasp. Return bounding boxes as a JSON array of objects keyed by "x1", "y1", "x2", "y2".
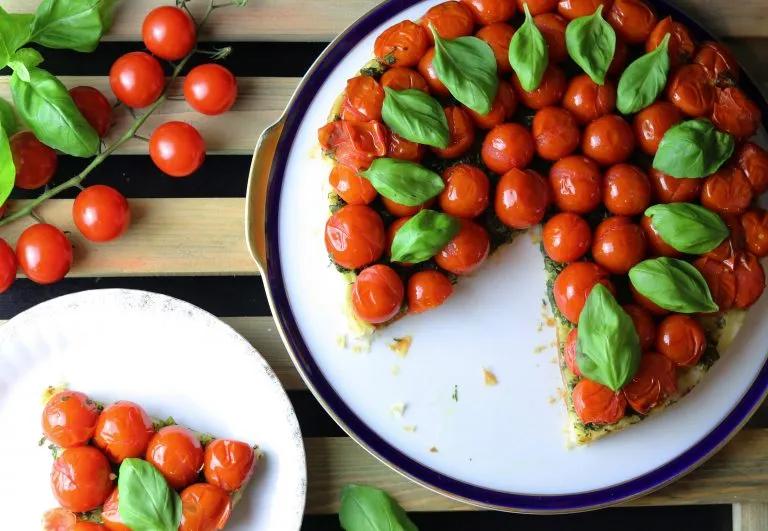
[{"x1": 565, "y1": 4, "x2": 616, "y2": 85}]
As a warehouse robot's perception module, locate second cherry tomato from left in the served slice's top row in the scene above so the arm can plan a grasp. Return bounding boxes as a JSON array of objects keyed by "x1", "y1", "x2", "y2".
[{"x1": 93, "y1": 400, "x2": 155, "y2": 463}]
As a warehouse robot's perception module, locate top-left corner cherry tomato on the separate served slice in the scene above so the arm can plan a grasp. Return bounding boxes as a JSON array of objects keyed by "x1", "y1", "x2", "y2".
[{"x1": 43, "y1": 391, "x2": 99, "y2": 448}]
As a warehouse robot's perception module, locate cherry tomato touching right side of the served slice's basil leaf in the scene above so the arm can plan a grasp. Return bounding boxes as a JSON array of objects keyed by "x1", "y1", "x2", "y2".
[{"x1": 179, "y1": 483, "x2": 232, "y2": 531}]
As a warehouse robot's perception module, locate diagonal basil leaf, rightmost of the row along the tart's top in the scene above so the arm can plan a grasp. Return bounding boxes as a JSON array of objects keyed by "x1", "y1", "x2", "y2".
[{"x1": 616, "y1": 33, "x2": 669, "y2": 114}]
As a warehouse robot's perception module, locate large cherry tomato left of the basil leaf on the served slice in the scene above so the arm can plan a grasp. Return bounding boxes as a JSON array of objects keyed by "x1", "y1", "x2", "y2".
[{"x1": 51, "y1": 446, "x2": 114, "y2": 513}]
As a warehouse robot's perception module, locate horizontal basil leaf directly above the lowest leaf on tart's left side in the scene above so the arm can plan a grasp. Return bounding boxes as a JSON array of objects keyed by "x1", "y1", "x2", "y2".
[{"x1": 360, "y1": 158, "x2": 445, "y2": 206}]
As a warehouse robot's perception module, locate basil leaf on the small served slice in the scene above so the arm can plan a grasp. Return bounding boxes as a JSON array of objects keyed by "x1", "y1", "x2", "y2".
[{"x1": 117, "y1": 458, "x2": 181, "y2": 531}]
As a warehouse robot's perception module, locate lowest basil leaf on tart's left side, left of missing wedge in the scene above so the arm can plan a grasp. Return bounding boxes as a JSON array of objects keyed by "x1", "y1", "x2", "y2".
[{"x1": 391, "y1": 210, "x2": 461, "y2": 264}]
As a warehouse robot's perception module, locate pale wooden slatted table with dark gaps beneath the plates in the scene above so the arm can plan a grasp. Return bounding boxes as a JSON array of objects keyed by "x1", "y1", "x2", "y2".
[{"x1": 0, "y1": 0, "x2": 768, "y2": 531}]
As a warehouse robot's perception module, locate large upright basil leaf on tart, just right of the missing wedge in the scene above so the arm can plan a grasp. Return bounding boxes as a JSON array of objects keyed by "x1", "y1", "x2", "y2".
[{"x1": 576, "y1": 284, "x2": 642, "y2": 391}]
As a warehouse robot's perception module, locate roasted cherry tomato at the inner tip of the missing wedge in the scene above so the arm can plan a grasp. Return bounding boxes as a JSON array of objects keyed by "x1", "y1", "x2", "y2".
[{"x1": 495, "y1": 168, "x2": 550, "y2": 229}]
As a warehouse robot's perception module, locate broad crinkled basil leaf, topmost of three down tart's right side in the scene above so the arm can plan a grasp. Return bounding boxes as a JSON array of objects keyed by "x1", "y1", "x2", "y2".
[{"x1": 653, "y1": 118, "x2": 735, "y2": 178}]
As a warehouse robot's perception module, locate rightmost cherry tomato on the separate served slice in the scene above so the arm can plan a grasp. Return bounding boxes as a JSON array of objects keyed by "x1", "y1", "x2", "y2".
[{"x1": 203, "y1": 439, "x2": 256, "y2": 492}]
